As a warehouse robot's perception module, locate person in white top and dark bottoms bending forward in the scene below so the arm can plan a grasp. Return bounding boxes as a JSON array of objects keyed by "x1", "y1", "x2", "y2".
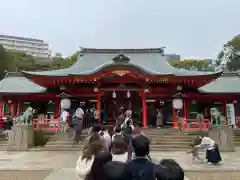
[{"x1": 196, "y1": 136, "x2": 222, "y2": 165}]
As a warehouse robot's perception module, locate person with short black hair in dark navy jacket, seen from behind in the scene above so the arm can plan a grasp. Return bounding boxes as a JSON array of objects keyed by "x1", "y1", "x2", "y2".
[{"x1": 122, "y1": 135, "x2": 156, "y2": 180}]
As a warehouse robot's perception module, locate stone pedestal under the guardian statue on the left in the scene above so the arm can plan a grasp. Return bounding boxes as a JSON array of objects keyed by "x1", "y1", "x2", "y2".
[{"x1": 7, "y1": 124, "x2": 34, "y2": 151}]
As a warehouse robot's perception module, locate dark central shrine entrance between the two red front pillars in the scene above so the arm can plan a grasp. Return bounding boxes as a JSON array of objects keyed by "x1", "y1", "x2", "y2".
[{"x1": 102, "y1": 89, "x2": 142, "y2": 125}]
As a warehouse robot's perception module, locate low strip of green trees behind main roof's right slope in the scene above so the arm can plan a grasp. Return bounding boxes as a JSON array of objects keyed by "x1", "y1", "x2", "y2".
[{"x1": 171, "y1": 59, "x2": 214, "y2": 71}]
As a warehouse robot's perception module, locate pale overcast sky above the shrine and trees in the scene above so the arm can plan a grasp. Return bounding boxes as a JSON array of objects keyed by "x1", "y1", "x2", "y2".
[{"x1": 0, "y1": 0, "x2": 240, "y2": 59}]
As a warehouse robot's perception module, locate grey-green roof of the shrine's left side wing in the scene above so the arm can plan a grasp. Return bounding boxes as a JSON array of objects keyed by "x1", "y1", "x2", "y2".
[{"x1": 0, "y1": 73, "x2": 45, "y2": 94}]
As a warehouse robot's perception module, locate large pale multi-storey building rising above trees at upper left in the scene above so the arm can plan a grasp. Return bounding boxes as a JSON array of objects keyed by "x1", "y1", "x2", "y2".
[{"x1": 0, "y1": 35, "x2": 51, "y2": 59}]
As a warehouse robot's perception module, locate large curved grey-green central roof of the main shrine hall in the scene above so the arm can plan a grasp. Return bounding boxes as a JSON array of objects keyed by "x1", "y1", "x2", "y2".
[{"x1": 21, "y1": 48, "x2": 221, "y2": 76}]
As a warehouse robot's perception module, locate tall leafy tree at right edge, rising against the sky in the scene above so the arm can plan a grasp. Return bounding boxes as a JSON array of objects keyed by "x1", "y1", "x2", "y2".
[{"x1": 216, "y1": 35, "x2": 240, "y2": 71}]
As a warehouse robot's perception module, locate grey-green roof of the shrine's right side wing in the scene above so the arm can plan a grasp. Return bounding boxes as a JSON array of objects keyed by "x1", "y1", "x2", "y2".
[{"x1": 198, "y1": 73, "x2": 240, "y2": 93}]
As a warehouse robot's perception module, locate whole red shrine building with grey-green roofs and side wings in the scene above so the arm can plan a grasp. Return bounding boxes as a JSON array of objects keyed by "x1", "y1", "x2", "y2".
[{"x1": 0, "y1": 48, "x2": 240, "y2": 128}]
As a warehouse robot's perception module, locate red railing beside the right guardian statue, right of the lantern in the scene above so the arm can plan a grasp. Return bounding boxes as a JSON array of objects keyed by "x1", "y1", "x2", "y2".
[{"x1": 182, "y1": 119, "x2": 209, "y2": 131}]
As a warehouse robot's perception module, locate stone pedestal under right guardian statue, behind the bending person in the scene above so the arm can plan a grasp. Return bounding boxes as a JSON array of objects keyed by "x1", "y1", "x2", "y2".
[{"x1": 208, "y1": 125, "x2": 235, "y2": 152}]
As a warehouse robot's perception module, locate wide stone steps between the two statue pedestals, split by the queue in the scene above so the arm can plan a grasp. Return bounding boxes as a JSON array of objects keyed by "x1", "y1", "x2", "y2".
[{"x1": 42, "y1": 128, "x2": 195, "y2": 151}]
